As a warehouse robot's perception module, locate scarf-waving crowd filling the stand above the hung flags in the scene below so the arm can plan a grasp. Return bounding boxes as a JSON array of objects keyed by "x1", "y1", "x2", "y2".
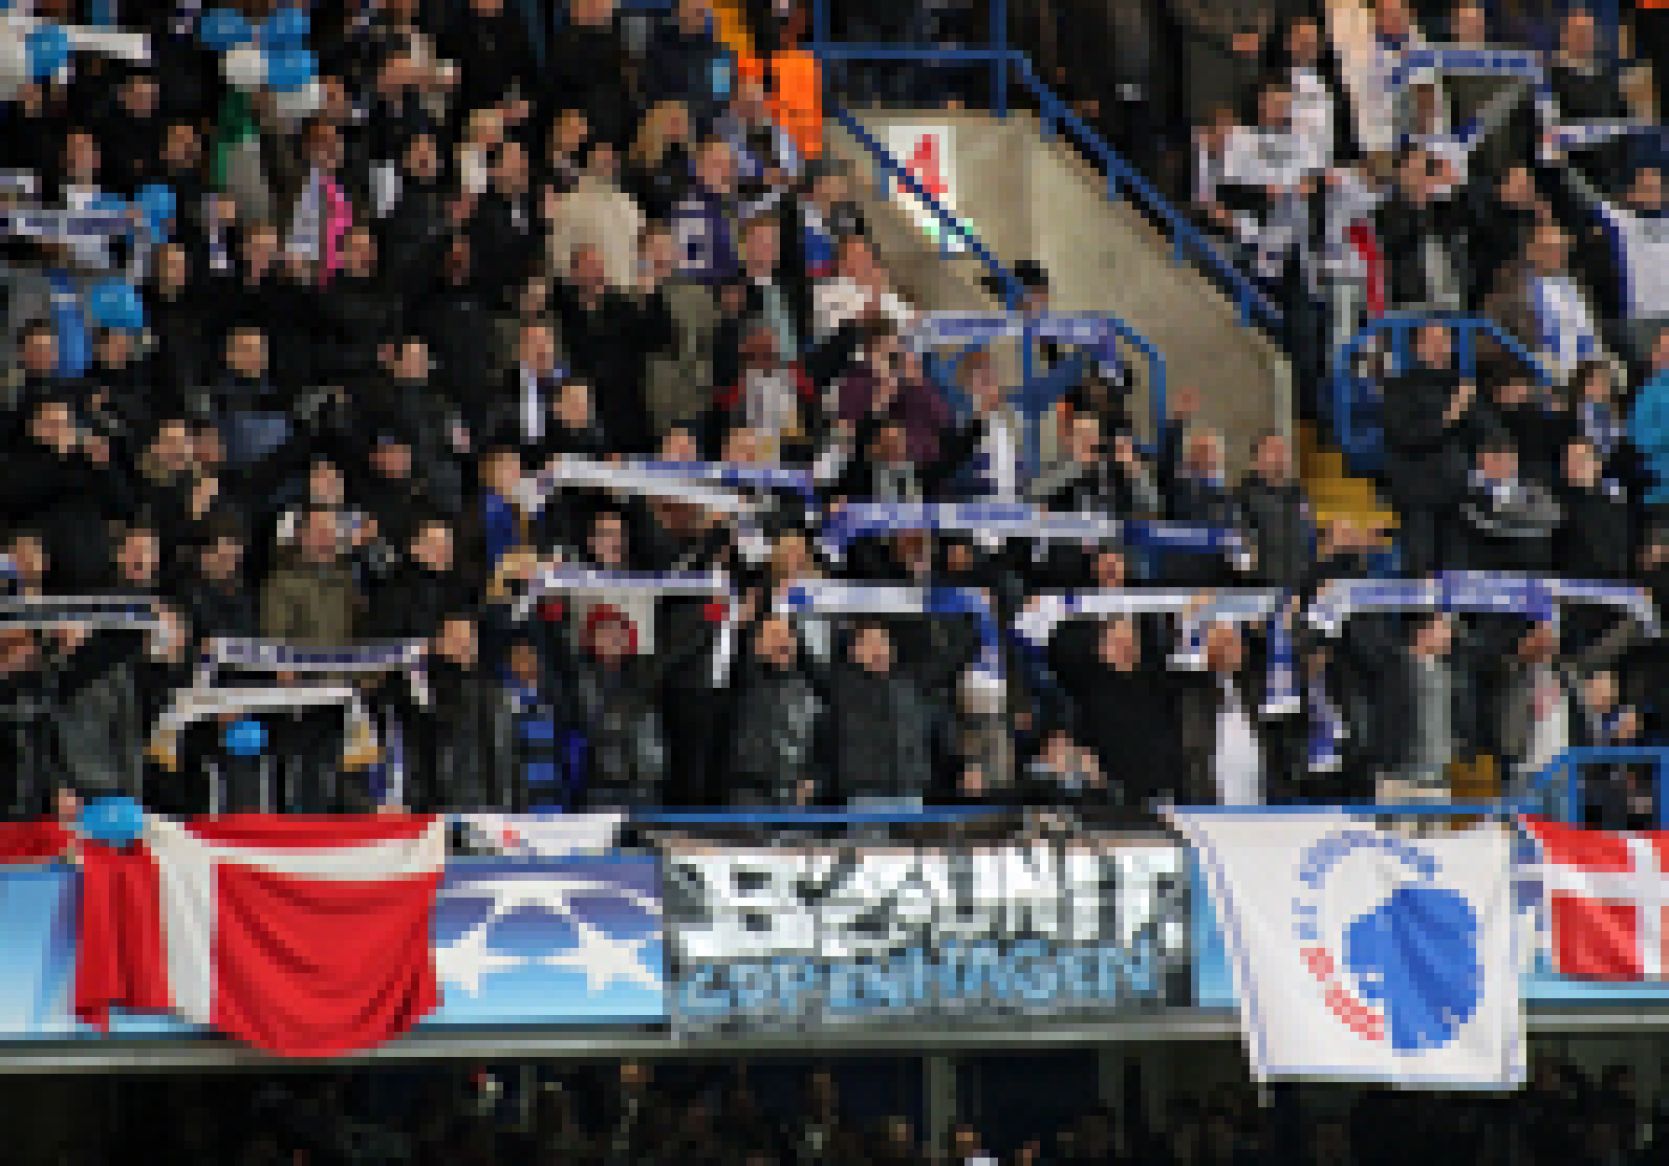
[{"x1": 0, "y1": 0, "x2": 1669, "y2": 824}]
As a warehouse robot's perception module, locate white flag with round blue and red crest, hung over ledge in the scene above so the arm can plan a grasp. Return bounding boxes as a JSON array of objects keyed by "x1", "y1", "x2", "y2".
[{"x1": 1172, "y1": 809, "x2": 1524, "y2": 1088}]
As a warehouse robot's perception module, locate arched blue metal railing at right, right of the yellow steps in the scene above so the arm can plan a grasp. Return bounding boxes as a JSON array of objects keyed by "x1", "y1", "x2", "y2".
[{"x1": 1332, "y1": 312, "x2": 1552, "y2": 470}]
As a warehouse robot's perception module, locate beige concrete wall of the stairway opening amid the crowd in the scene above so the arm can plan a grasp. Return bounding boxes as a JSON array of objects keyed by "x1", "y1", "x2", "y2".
[{"x1": 847, "y1": 110, "x2": 1292, "y2": 467}]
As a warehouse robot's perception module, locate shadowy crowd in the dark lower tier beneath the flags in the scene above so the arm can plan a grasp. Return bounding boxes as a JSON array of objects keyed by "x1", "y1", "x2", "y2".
[{"x1": 57, "y1": 1059, "x2": 1662, "y2": 1166}]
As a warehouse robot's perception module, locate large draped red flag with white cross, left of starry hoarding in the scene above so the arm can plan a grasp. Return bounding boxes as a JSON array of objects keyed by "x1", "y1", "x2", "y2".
[{"x1": 75, "y1": 816, "x2": 446, "y2": 1056}]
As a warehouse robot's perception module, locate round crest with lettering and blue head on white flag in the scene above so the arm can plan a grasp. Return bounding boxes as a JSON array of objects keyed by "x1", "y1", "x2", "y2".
[{"x1": 1292, "y1": 829, "x2": 1484, "y2": 1051}]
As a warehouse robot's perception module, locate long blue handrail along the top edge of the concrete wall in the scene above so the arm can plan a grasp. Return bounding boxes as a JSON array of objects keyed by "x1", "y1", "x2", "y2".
[{"x1": 809, "y1": 39, "x2": 1283, "y2": 329}]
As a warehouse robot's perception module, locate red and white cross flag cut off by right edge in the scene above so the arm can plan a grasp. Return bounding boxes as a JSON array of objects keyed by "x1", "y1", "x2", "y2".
[{"x1": 1524, "y1": 817, "x2": 1669, "y2": 979}]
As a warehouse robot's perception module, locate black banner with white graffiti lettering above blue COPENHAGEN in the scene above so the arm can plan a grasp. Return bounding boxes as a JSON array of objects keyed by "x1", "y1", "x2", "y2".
[{"x1": 663, "y1": 836, "x2": 1190, "y2": 1033}]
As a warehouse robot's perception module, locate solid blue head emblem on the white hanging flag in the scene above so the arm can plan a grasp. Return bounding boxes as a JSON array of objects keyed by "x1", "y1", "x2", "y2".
[{"x1": 1345, "y1": 886, "x2": 1484, "y2": 1053}]
